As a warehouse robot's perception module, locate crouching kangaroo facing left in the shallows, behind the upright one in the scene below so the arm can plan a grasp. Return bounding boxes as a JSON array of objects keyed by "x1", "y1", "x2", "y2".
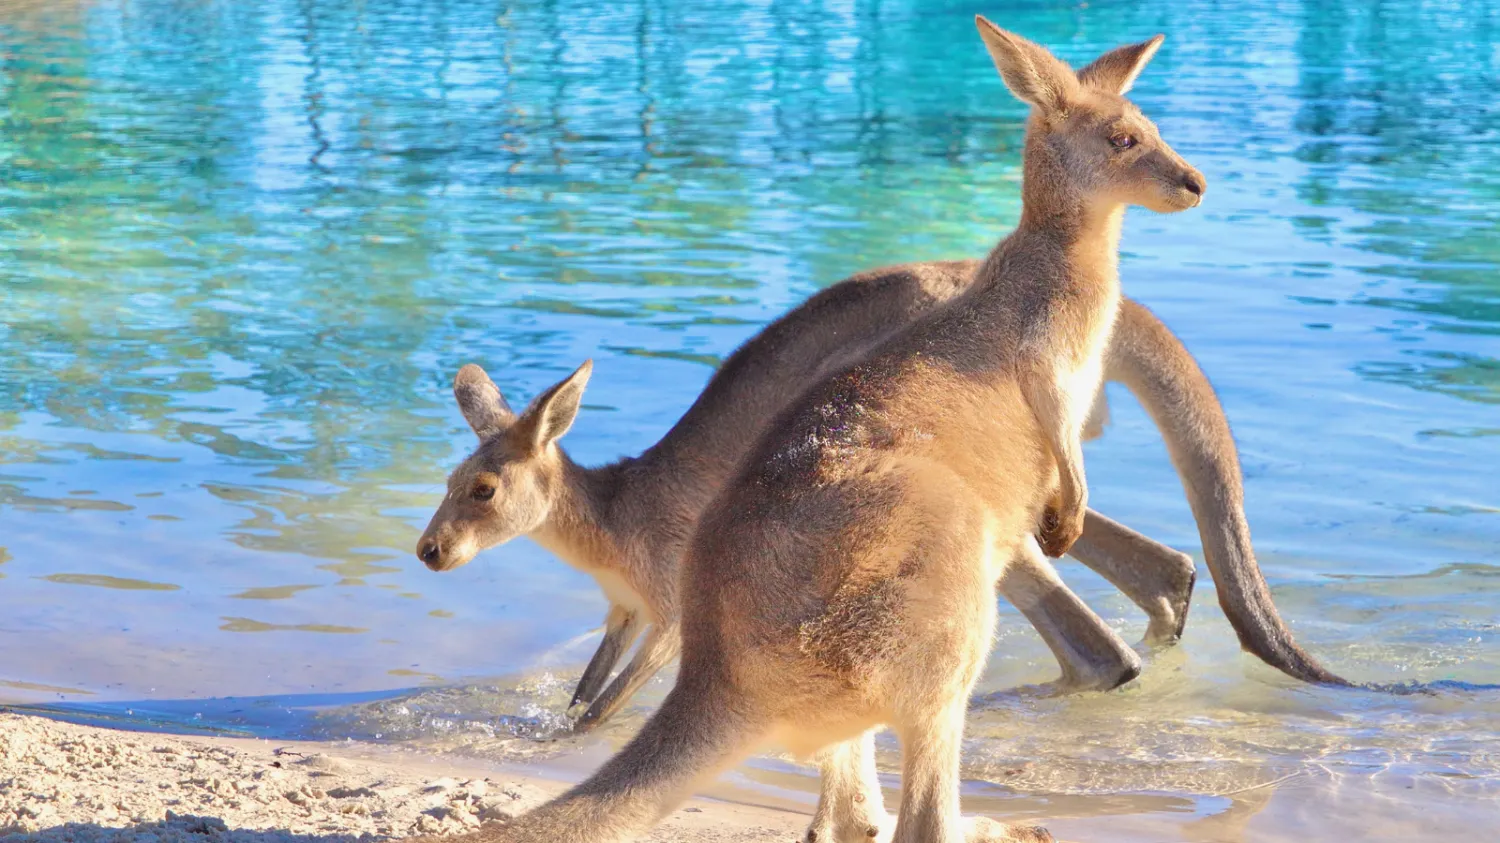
[{"x1": 417, "y1": 37, "x2": 1346, "y2": 729}]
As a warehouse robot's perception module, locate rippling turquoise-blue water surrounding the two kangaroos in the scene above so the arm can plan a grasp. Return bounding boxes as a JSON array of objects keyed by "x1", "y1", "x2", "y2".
[{"x1": 0, "y1": 0, "x2": 1500, "y2": 840}]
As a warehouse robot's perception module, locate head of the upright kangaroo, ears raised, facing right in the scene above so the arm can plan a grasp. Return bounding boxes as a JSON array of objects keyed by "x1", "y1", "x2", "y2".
[{"x1": 975, "y1": 17, "x2": 1206, "y2": 213}]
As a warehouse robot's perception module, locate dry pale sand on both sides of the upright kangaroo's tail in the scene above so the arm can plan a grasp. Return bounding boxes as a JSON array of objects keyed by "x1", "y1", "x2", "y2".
[{"x1": 0, "y1": 714, "x2": 807, "y2": 843}]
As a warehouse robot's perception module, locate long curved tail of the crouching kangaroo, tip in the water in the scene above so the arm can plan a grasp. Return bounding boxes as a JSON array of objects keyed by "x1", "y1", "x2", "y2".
[{"x1": 1107, "y1": 300, "x2": 1353, "y2": 686}]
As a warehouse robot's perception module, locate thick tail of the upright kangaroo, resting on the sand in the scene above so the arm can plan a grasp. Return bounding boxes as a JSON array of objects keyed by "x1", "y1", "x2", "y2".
[{"x1": 468, "y1": 668, "x2": 759, "y2": 843}]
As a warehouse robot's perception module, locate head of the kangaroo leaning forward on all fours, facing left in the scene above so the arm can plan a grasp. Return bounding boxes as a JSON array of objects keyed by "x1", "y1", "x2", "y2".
[{"x1": 417, "y1": 360, "x2": 594, "y2": 572}]
